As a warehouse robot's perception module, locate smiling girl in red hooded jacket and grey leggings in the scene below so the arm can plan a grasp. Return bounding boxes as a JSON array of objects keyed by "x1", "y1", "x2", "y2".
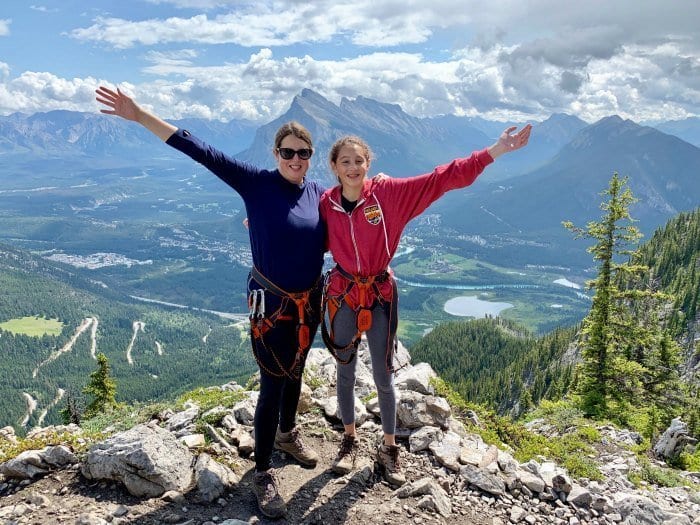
[{"x1": 321, "y1": 125, "x2": 531, "y2": 485}]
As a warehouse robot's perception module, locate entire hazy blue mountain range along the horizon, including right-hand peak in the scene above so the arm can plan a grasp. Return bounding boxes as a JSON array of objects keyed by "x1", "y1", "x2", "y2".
[{"x1": 0, "y1": 89, "x2": 700, "y2": 266}]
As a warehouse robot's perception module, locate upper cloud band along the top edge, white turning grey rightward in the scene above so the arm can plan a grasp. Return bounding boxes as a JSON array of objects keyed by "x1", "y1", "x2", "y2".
[{"x1": 72, "y1": 0, "x2": 700, "y2": 52}]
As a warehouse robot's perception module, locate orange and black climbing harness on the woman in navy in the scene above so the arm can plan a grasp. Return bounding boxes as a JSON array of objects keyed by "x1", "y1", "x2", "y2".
[{"x1": 248, "y1": 267, "x2": 320, "y2": 380}]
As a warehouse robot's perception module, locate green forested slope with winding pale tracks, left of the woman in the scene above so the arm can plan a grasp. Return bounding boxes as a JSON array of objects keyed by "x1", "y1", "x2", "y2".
[{"x1": 0, "y1": 246, "x2": 257, "y2": 432}]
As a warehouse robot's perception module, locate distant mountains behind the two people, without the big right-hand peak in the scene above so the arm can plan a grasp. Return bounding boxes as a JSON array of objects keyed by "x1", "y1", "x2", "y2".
[{"x1": 0, "y1": 89, "x2": 700, "y2": 180}]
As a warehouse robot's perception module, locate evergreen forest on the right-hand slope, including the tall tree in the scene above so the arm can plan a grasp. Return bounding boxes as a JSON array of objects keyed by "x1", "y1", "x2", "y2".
[{"x1": 411, "y1": 190, "x2": 700, "y2": 433}]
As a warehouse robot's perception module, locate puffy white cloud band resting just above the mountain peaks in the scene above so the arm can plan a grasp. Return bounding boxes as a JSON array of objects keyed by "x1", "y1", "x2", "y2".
[{"x1": 0, "y1": 38, "x2": 700, "y2": 123}]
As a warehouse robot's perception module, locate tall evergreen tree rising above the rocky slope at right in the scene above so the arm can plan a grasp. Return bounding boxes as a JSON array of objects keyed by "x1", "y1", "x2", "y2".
[{"x1": 564, "y1": 173, "x2": 680, "y2": 419}]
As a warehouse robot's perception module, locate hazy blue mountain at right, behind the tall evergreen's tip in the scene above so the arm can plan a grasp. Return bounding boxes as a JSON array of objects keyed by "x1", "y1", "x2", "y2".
[{"x1": 438, "y1": 116, "x2": 700, "y2": 236}]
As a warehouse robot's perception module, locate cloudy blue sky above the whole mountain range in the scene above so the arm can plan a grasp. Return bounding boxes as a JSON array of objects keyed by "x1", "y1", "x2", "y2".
[{"x1": 0, "y1": 0, "x2": 700, "y2": 124}]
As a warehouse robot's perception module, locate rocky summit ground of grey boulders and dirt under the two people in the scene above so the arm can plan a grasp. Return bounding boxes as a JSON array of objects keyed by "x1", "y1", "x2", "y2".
[{"x1": 0, "y1": 347, "x2": 700, "y2": 525}]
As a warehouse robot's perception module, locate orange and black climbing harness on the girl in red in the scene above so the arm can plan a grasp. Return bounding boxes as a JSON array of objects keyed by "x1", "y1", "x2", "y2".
[{"x1": 321, "y1": 265, "x2": 398, "y2": 369}]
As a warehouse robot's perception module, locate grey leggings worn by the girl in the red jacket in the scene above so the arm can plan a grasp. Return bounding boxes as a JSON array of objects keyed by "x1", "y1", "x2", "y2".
[{"x1": 333, "y1": 302, "x2": 396, "y2": 434}]
